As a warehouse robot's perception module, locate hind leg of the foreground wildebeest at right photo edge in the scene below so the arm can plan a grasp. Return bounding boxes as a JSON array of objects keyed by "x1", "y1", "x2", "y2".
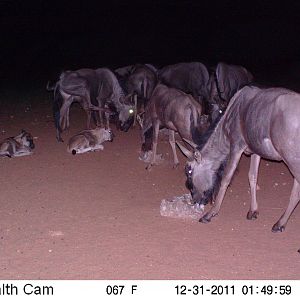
[{"x1": 272, "y1": 178, "x2": 300, "y2": 232}]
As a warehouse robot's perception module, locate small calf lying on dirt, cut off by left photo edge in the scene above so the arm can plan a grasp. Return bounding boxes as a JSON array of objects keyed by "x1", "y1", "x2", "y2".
[{"x1": 0, "y1": 130, "x2": 34, "y2": 157}]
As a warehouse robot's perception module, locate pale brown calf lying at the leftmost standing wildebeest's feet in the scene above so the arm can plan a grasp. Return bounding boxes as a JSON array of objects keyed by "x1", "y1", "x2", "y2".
[{"x1": 67, "y1": 127, "x2": 114, "y2": 155}]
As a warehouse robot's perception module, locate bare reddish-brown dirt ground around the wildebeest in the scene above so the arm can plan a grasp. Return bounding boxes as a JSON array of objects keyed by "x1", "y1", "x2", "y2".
[{"x1": 0, "y1": 91, "x2": 300, "y2": 279}]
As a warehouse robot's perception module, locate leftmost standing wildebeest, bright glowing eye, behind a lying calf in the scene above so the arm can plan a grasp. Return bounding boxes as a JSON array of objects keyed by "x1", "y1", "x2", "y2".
[{"x1": 53, "y1": 68, "x2": 134, "y2": 141}]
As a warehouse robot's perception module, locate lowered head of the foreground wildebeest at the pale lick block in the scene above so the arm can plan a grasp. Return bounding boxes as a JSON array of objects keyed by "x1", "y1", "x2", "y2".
[{"x1": 177, "y1": 143, "x2": 226, "y2": 205}]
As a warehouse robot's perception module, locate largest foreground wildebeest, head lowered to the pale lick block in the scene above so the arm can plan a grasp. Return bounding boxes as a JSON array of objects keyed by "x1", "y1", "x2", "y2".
[{"x1": 180, "y1": 87, "x2": 300, "y2": 232}]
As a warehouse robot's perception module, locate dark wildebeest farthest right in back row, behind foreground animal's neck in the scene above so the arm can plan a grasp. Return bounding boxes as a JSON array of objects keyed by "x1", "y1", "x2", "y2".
[{"x1": 208, "y1": 62, "x2": 253, "y2": 119}]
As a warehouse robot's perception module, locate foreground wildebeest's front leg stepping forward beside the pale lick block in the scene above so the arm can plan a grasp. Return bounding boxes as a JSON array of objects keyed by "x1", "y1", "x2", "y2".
[{"x1": 199, "y1": 151, "x2": 243, "y2": 223}]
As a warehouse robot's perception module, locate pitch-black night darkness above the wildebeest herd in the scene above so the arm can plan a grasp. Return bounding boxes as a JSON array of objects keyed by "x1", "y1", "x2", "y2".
[{"x1": 0, "y1": 0, "x2": 300, "y2": 88}]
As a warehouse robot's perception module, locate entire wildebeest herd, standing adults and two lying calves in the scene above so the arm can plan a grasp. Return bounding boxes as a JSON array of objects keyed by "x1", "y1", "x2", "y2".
[{"x1": 0, "y1": 62, "x2": 300, "y2": 251}]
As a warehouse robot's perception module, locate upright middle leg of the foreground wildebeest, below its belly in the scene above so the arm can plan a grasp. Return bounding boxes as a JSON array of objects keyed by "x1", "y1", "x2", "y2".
[{"x1": 247, "y1": 154, "x2": 260, "y2": 220}]
